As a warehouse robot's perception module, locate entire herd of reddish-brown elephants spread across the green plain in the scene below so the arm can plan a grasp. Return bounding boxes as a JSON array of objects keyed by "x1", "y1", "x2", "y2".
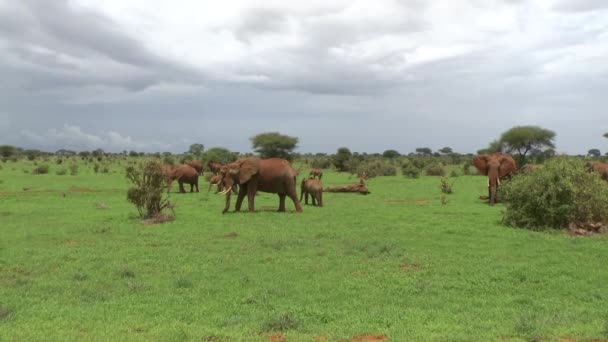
[{"x1": 163, "y1": 152, "x2": 608, "y2": 213}]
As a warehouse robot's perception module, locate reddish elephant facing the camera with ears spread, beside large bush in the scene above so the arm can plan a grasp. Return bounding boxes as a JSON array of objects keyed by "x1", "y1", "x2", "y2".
[{"x1": 473, "y1": 152, "x2": 517, "y2": 205}]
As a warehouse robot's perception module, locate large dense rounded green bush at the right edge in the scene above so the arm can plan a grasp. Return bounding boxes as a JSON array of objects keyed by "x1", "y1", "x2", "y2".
[{"x1": 499, "y1": 158, "x2": 608, "y2": 228}]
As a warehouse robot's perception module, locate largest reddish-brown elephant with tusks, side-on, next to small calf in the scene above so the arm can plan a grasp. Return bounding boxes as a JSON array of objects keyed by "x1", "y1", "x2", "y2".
[{"x1": 219, "y1": 157, "x2": 302, "y2": 213}]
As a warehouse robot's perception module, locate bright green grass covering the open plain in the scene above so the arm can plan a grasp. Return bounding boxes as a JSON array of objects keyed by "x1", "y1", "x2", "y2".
[{"x1": 0, "y1": 162, "x2": 608, "y2": 341}]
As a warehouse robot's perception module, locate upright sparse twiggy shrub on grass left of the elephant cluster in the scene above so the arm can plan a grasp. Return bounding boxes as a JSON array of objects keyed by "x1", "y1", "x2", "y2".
[{"x1": 126, "y1": 160, "x2": 172, "y2": 219}]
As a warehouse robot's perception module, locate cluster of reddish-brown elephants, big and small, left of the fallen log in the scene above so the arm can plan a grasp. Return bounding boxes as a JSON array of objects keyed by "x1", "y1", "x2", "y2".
[{"x1": 163, "y1": 157, "x2": 323, "y2": 213}]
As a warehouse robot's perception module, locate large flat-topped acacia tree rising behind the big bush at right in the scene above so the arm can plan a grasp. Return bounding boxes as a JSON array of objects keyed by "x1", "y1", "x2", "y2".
[{"x1": 500, "y1": 126, "x2": 555, "y2": 166}]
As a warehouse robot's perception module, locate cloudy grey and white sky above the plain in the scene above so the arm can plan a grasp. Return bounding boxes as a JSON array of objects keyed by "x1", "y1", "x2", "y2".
[{"x1": 0, "y1": 0, "x2": 608, "y2": 154}]
